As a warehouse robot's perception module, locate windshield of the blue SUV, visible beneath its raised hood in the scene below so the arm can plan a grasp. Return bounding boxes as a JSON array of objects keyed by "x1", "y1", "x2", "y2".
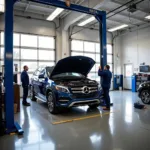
[{"x1": 53, "y1": 72, "x2": 84, "y2": 78}]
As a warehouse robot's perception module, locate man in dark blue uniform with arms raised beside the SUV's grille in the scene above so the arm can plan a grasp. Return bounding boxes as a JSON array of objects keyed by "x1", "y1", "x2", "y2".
[{"x1": 98, "y1": 65, "x2": 112, "y2": 110}]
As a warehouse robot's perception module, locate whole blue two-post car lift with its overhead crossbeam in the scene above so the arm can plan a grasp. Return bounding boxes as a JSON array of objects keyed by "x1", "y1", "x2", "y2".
[{"x1": 4, "y1": 0, "x2": 107, "y2": 134}]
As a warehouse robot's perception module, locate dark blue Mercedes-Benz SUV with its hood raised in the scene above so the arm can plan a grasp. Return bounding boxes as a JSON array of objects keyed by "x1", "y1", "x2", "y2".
[{"x1": 31, "y1": 56, "x2": 102, "y2": 113}]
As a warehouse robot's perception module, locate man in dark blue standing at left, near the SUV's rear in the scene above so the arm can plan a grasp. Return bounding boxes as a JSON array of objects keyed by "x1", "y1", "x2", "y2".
[{"x1": 21, "y1": 66, "x2": 30, "y2": 106}]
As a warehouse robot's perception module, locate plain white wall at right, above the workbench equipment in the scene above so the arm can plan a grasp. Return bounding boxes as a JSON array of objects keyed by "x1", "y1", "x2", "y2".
[{"x1": 118, "y1": 27, "x2": 150, "y2": 73}]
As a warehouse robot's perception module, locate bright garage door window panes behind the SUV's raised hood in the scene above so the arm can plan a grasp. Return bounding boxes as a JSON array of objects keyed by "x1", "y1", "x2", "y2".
[{"x1": 71, "y1": 40, "x2": 113, "y2": 82}]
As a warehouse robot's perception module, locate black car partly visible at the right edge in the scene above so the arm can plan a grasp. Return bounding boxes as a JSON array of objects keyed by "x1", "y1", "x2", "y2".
[{"x1": 137, "y1": 81, "x2": 150, "y2": 104}]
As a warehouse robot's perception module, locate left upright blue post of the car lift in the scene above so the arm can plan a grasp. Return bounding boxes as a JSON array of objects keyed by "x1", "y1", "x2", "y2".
[{"x1": 4, "y1": 0, "x2": 15, "y2": 133}]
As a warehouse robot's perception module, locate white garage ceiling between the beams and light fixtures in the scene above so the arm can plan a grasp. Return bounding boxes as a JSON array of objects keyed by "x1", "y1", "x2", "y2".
[{"x1": 14, "y1": 0, "x2": 150, "y2": 31}]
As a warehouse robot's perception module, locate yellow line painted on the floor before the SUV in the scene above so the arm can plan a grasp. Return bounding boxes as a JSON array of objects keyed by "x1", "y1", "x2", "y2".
[{"x1": 52, "y1": 112, "x2": 114, "y2": 125}]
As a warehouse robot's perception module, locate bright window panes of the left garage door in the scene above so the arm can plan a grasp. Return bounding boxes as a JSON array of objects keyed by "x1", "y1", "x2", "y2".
[{"x1": 0, "y1": 32, "x2": 55, "y2": 77}]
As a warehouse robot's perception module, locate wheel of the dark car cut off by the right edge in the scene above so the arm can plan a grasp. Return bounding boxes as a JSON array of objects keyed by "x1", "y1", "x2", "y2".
[{"x1": 140, "y1": 90, "x2": 150, "y2": 104}]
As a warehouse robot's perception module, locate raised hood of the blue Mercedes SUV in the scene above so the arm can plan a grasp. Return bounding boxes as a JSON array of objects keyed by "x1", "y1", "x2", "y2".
[{"x1": 50, "y1": 56, "x2": 95, "y2": 78}]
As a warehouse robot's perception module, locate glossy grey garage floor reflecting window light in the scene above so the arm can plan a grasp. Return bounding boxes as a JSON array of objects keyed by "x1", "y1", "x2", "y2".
[{"x1": 0, "y1": 91, "x2": 150, "y2": 150}]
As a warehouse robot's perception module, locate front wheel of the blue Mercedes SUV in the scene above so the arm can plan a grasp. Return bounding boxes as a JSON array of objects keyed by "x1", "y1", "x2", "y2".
[{"x1": 47, "y1": 92, "x2": 58, "y2": 114}]
